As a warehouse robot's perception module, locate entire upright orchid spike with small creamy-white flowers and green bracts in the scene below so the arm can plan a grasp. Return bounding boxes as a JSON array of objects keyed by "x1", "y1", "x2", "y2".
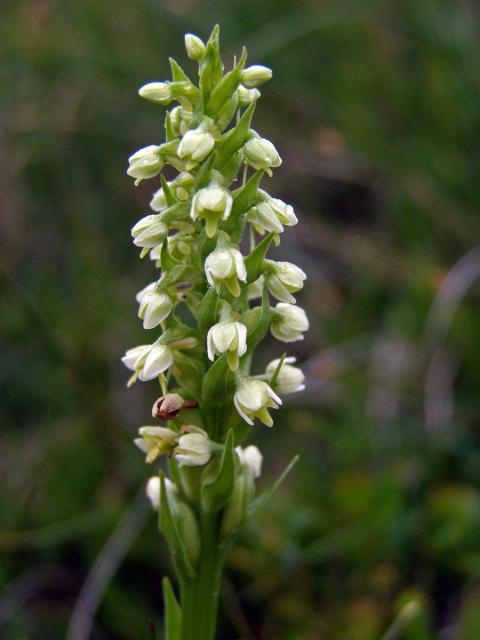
[{"x1": 123, "y1": 27, "x2": 308, "y2": 640}]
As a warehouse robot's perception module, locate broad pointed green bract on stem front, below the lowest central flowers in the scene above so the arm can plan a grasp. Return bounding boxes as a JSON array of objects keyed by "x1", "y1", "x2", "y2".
[{"x1": 202, "y1": 429, "x2": 235, "y2": 511}]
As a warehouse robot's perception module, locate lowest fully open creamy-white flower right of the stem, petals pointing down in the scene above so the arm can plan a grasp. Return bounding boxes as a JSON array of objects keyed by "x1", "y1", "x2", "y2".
[{"x1": 233, "y1": 378, "x2": 282, "y2": 427}]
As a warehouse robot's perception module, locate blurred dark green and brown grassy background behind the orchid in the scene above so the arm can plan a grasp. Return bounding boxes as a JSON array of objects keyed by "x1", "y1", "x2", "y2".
[{"x1": 0, "y1": 0, "x2": 480, "y2": 640}]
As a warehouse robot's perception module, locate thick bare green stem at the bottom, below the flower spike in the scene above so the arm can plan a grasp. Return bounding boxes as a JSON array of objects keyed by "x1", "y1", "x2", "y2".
[{"x1": 180, "y1": 514, "x2": 224, "y2": 640}]
